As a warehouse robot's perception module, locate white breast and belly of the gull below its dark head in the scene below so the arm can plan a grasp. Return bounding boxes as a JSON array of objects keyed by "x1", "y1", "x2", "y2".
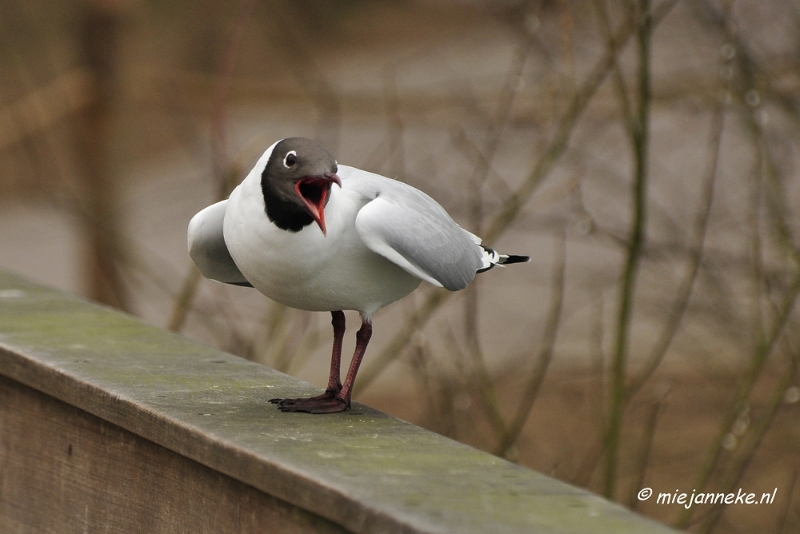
[{"x1": 219, "y1": 174, "x2": 420, "y2": 317}]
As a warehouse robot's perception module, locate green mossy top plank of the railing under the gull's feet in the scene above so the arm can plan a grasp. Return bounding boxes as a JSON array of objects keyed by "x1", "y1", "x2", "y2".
[{"x1": 0, "y1": 272, "x2": 673, "y2": 534}]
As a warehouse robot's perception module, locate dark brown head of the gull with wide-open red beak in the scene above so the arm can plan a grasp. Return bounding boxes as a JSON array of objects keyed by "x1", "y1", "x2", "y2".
[{"x1": 261, "y1": 137, "x2": 342, "y2": 234}]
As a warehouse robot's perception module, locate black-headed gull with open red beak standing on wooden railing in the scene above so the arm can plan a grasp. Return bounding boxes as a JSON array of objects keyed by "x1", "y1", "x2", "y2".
[{"x1": 188, "y1": 137, "x2": 530, "y2": 413}]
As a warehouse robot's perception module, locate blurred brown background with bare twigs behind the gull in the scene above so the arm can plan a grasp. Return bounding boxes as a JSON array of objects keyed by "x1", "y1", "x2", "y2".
[{"x1": 0, "y1": 0, "x2": 800, "y2": 533}]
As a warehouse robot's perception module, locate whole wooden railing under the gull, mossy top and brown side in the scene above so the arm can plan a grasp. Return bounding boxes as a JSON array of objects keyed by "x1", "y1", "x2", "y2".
[{"x1": 0, "y1": 272, "x2": 672, "y2": 534}]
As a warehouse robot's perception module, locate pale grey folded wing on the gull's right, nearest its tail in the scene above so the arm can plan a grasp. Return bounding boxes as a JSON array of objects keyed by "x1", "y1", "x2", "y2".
[{"x1": 356, "y1": 171, "x2": 483, "y2": 291}]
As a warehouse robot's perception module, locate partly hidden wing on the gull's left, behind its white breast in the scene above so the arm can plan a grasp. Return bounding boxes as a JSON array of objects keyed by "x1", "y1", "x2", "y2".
[{"x1": 187, "y1": 200, "x2": 253, "y2": 287}]
